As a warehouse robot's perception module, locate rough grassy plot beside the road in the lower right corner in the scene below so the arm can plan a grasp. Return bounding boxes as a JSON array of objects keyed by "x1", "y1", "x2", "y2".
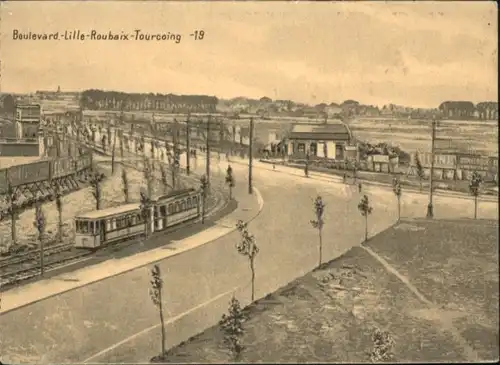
[{"x1": 158, "y1": 221, "x2": 498, "y2": 362}]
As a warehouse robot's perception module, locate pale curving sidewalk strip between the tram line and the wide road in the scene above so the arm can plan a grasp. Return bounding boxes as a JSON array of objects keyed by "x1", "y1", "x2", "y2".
[{"x1": 0, "y1": 183, "x2": 264, "y2": 314}]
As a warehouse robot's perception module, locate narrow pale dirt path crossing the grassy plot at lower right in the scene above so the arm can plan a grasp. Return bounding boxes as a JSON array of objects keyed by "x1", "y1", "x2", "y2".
[{"x1": 361, "y1": 245, "x2": 482, "y2": 362}]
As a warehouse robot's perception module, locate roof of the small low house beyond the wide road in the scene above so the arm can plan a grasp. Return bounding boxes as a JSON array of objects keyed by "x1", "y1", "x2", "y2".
[{"x1": 289, "y1": 119, "x2": 352, "y2": 141}]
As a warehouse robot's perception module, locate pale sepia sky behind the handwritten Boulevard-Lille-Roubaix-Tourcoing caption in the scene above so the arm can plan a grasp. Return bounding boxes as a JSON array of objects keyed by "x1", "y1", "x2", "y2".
[{"x1": 0, "y1": 1, "x2": 498, "y2": 107}]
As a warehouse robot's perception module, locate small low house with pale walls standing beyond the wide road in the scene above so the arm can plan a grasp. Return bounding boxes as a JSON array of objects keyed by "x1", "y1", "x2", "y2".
[{"x1": 288, "y1": 120, "x2": 352, "y2": 160}]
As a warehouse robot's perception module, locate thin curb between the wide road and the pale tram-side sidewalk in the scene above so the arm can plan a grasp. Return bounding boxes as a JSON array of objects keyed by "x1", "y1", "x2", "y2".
[{"x1": 0, "y1": 187, "x2": 264, "y2": 316}]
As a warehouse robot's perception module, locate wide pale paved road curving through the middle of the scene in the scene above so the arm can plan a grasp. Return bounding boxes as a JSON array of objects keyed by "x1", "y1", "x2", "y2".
[{"x1": 0, "y1": 151, "x2": 498, "y2": 363}]
